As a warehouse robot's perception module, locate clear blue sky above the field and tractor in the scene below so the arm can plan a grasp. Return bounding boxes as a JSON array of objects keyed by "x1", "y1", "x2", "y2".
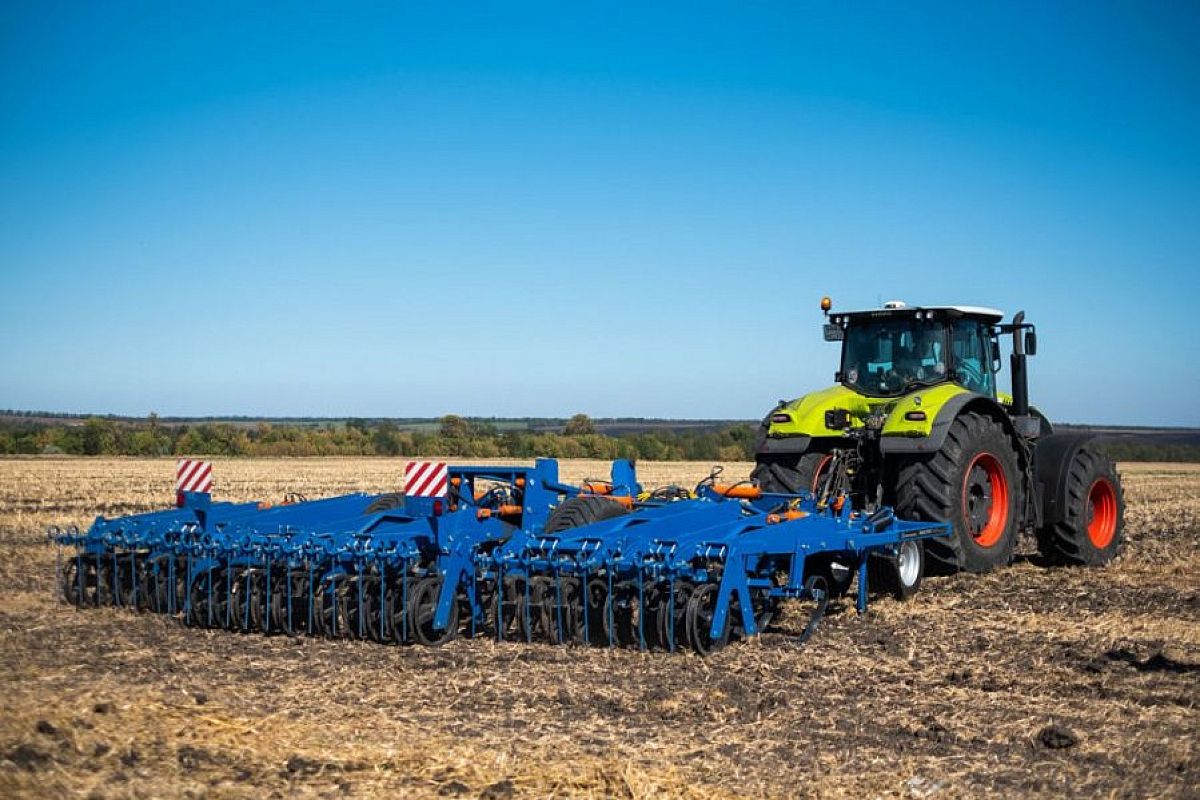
[{"x1": 0, "y1": 1, "x2": 1200, "y2": 426}]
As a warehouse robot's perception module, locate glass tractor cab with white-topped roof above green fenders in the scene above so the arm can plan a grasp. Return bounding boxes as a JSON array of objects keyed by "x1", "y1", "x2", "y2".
[{"x1": 824, "y1": 301, "x2": 1003, "y2": 398}]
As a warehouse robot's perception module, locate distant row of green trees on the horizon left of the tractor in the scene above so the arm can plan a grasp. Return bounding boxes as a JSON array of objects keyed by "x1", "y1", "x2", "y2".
[{"x1": 0, "y1": 414, "x2": 755, "y2": 461}]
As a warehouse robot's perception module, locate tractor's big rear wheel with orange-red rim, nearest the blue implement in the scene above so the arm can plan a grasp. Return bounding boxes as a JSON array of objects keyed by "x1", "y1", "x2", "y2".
[{"x1": 896, "y1": 411, "x2": 1025, "y2": 572}]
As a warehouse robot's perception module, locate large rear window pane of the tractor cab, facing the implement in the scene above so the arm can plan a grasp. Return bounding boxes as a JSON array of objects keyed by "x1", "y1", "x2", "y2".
[{"x1": 841, "y1": 318, "x2": 947, "y2": 397}]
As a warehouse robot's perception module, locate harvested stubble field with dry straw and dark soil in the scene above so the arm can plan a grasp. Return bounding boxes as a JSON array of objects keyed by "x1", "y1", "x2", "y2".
[{"x1": 0, "y1": 458, "x2": 1200, "y2": 799}]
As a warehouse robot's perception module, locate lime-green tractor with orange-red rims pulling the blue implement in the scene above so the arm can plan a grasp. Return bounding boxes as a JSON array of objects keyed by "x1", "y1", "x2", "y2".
[{"x1": 751, "y1": 297, "x2": 1124, "y2": 579}]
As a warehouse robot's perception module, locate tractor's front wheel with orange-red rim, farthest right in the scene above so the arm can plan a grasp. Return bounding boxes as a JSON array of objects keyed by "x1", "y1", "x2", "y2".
[{"x1": 1038, "y1": 443, "x2": 1124, "y2": 566}]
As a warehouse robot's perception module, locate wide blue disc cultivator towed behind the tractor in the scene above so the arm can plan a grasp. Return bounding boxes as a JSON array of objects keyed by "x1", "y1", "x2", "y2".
[{"x1": 49, "y1": 459, "x2": 948, "y2": 654}]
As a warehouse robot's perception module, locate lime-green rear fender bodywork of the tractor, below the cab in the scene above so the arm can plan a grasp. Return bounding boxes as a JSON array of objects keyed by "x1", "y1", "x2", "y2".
[{"x1": 760, "y1": 383, "x2": 971, "y2": 452}]
